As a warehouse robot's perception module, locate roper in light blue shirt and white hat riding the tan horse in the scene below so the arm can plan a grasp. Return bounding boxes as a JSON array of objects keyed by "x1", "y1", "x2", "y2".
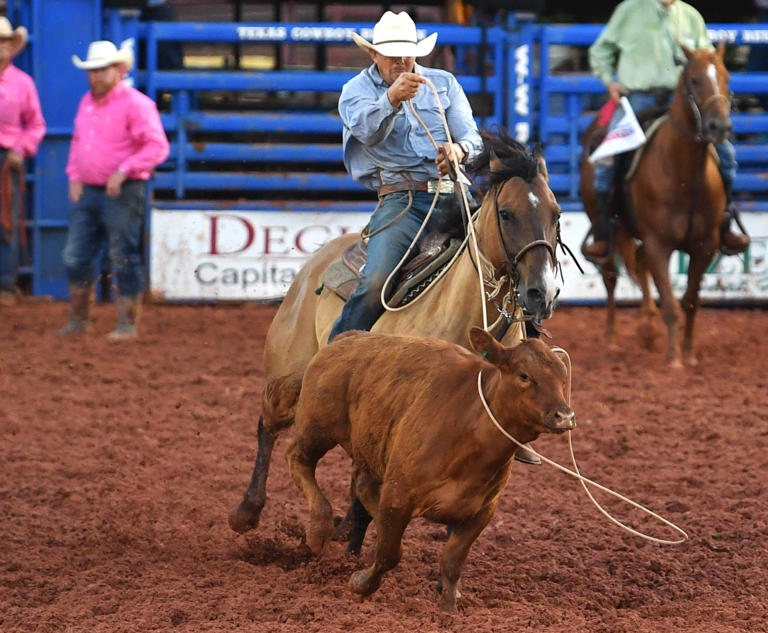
[{"x1": 329, "y1": 11, "x2": 483, "y2": 340}]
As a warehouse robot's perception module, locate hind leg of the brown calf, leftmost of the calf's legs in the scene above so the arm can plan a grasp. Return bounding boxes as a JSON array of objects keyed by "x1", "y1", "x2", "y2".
[{"x1": 285, "y1": 433, "x2": 336, "y2": 554}]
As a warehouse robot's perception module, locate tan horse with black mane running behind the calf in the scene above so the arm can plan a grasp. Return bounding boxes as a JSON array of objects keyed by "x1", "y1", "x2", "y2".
[{"x1": 229, "y1": 134, "x2": 560, "y2": 533}]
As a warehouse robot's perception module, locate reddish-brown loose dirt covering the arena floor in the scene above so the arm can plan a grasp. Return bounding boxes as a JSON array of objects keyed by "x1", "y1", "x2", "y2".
[{"x1": 0, "y1": 303, "x2": 768, "y2": 633}]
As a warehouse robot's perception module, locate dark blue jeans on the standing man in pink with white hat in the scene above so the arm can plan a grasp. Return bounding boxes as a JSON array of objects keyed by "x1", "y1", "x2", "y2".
[{"x1": 63, "y1": 180, "x2": 147, "y2": 297}]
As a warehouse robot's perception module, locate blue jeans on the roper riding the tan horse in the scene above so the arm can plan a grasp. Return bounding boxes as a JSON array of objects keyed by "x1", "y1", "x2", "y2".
[{"x1": 328, "y1": 191, "x2": 452, "y2": 341}]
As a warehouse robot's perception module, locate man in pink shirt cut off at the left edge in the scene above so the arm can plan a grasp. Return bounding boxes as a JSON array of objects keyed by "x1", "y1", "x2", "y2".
[{"x1": 0, "y1": 17, "x2": 45, "y2": 303}]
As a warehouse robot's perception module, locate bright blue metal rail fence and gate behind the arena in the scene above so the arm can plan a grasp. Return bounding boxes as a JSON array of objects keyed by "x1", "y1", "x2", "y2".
[{"x1": 9, "y1": 0, "x2": 768, "y2": 297}]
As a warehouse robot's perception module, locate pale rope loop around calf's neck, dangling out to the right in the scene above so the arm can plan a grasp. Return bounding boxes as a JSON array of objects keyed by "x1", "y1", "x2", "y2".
[{"x1": 477, "y1": 347, "x2": 688, "y2": 545}]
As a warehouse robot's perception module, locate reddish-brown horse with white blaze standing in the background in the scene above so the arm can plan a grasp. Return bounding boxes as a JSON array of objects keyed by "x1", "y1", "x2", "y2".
[{"x1": 581, "y1": 44, "x2": 732, "y2": 367}]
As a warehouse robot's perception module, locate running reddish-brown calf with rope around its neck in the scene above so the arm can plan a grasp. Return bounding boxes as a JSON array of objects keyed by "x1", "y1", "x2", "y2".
[{"x1": 280, "y1": 328, "x2": 574, "y2": 612}]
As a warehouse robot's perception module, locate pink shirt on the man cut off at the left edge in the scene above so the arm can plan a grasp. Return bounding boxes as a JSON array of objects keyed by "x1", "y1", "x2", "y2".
[{"x1": 0, "y1": 64, "x2": 45, "y2": 156}]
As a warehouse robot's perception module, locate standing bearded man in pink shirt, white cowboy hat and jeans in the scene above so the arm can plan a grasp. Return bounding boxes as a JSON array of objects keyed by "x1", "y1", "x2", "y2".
[{"x1": 59, "y1": 41, "x2": 168, "y2": 340}]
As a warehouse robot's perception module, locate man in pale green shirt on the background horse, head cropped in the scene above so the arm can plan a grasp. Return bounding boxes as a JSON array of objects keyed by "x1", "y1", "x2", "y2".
[{"x1": 584, "y1": 0, "x2": 749, "y2": 261}]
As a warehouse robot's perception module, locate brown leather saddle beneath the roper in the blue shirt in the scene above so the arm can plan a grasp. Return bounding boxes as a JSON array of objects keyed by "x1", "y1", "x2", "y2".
[{"x1": 323, "y1": 231, "x2": 461, "y2": 307}]
